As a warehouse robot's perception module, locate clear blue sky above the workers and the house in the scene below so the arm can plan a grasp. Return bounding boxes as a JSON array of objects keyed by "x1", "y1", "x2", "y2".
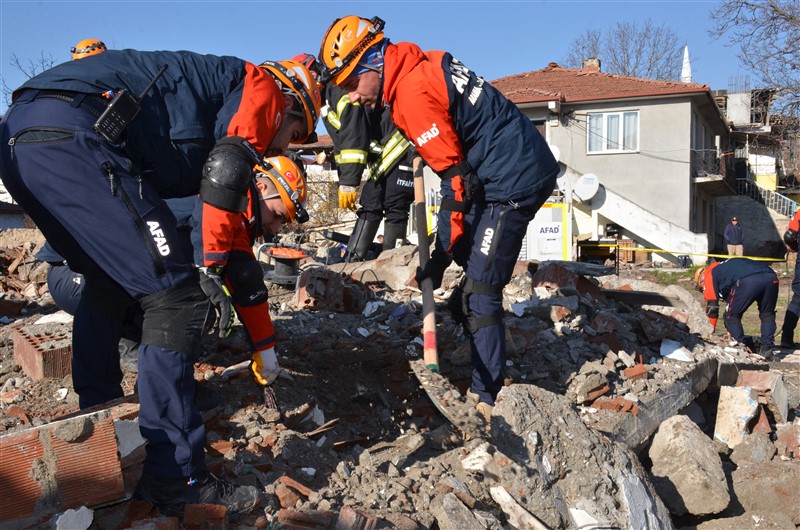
[{"x1": 0, "y1": 0, "x2": 747, "y2": 120}]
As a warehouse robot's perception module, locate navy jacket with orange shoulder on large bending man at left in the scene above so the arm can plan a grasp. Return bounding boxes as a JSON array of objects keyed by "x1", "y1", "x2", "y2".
[{"x1": 15, "y1": 50, "x2": 284, "y2": 198}]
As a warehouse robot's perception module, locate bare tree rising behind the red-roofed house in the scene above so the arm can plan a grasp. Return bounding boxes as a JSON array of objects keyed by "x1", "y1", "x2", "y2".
[{"x1": 562, "y1": 19, "x2": 683, "y2": 80}]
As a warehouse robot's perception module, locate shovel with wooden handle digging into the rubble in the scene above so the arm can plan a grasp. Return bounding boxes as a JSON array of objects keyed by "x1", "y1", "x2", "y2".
[{"x1": 409, "y1": 157, "x2": 486, "y2": 440}]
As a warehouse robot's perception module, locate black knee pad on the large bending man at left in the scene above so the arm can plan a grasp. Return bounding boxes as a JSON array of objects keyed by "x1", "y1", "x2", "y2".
[{"x1": 139, "y1": 281, "x2": 208, "y2": 359}]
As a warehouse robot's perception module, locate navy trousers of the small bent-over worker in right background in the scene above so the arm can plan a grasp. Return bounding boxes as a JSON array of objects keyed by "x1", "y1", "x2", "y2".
[{"x1": 723, "y1": 272, "x2": 778, "y2": 348}]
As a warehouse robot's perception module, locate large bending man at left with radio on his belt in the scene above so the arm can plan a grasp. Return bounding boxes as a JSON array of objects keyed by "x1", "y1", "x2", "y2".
[{"x1": 0, "y1": 50, "x2": 320, "y2": 515}]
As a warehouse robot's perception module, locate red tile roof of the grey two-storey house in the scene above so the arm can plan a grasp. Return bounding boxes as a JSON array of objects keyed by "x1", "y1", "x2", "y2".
[{"x1": 491, "y1": 63, "x2": 710, "y2": 105}]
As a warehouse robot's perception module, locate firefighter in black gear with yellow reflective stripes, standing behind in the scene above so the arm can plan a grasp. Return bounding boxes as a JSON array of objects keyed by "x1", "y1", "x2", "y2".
[{"x1": 322, "y1": 58, "x2": 415, "y2": 261}]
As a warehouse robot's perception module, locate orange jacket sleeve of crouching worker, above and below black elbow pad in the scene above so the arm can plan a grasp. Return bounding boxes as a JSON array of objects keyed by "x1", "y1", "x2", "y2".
[{"x1": 197, "y1": 186, "x2": 275, "y2": 350}]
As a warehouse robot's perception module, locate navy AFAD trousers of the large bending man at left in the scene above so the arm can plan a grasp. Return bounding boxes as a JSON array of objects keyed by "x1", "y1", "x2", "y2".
[{"x1": 0, "y1": 94, "x2": 205, "y2": 477}]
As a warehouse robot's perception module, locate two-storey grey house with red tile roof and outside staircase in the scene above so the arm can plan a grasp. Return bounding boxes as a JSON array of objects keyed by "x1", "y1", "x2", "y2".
[{"x1": 491, "y1": 59, "x2": 735, "y2": 263}]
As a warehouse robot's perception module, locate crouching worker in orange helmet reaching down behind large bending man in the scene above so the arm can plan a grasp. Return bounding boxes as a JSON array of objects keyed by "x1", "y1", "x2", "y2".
[{"x1": 195, "y1": 156, "x2": 308, "y2": 385}]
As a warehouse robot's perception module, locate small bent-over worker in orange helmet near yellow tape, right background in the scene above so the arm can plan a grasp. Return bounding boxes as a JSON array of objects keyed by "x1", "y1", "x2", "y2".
[{"x1": 695, "y1": 258, "x2": 778, "y2": 356}]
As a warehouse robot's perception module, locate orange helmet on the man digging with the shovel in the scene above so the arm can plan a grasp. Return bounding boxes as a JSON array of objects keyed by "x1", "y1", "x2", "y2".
[{"x1": 319, "y1": 15, "x2": 385, "y2": 85}]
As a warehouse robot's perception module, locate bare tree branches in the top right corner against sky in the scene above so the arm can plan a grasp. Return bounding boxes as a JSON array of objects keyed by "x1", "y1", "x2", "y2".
[{"x1": 709, "y1": 0, "x2": 800, "y2": 116}]
